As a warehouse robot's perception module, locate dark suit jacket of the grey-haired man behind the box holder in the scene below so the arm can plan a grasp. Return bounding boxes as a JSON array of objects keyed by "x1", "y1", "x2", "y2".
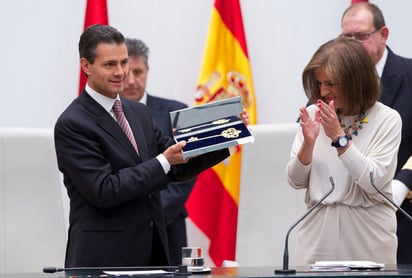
[{"x1": 146, "y1": 95, "x2": 196, "y2": 265}]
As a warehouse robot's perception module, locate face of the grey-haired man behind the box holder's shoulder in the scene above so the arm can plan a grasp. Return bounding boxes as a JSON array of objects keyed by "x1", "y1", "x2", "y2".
[{"x1": 122, "y1": 57, "x2": 149, "y2": 101}]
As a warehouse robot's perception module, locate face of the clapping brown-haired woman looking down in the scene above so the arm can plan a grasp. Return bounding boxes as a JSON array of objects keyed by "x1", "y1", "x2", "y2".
[{"x1": 315, "y1": 69, "x2": 343, "y2": 109}]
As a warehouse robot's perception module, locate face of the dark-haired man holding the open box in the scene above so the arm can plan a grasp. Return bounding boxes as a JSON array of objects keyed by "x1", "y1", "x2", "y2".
[{"x1": 80, "y1": 43, "x2": 129, "y2": 98}]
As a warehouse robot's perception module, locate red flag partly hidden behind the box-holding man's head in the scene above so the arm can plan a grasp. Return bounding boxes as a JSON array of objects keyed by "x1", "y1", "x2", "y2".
[{"x1": 79, "y1": 0, "x2": 109, "y2": 95}]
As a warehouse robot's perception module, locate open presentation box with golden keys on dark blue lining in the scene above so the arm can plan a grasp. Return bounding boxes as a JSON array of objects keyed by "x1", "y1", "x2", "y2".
[{"x1": 170, "y1": 97, "x2": 254, "y2": 158}]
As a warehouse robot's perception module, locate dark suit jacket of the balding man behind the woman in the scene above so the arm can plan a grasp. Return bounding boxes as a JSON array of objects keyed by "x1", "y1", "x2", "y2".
[{"x1": 380, "y1": 48, "x2": 412, "y2": 264}]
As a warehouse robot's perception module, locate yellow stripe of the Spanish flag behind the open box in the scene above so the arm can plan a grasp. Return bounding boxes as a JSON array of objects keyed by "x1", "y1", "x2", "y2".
[{"x1": 197, "y1": 4, "x2": 257, "y2": 204}]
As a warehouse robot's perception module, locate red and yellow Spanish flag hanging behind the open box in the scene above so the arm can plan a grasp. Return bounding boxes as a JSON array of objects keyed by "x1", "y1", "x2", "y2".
[{"x1": 186, "y1": 0, "x2": 256, "y2": 266}]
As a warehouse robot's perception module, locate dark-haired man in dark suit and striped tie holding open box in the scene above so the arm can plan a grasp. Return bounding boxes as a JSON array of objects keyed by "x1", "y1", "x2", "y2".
[{"x1": 54, "y1": 25, "x2": 233, "y2": 267}]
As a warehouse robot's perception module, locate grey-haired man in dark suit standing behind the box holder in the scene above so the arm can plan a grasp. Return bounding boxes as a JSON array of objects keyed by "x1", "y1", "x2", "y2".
[{"x1": 121, "y1": 38, "x2": 196, "y2": 265}]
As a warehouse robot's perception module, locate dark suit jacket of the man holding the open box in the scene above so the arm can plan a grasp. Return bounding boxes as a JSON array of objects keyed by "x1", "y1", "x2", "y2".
[{"x1": 54, "y1": 91, "x2": 229, "y2": 267}]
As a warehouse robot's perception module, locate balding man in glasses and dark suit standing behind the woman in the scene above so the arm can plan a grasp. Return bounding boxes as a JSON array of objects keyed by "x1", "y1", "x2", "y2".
[{"x1": 341, "y1": 2, "x2": 412, "y2": 264}]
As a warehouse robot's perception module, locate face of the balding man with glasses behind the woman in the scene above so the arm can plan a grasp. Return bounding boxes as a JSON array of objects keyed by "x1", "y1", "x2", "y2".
[{"x1": 342, "y1": 9, "x2": 389, "y2": 64}]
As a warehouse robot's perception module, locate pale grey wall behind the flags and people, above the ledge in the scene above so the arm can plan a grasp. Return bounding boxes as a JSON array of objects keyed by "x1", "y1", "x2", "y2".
[{"x1": 0, "y1": 0, "x2": 412, "y2": 128}]
